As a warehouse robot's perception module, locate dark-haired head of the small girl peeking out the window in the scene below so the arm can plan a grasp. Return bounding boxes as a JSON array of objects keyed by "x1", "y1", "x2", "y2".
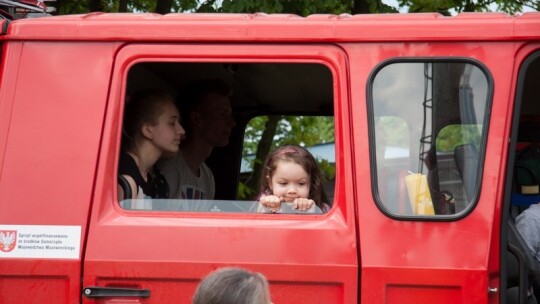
[{"x1": 261, "y1": 145, "x2": 328, "y2": 207}]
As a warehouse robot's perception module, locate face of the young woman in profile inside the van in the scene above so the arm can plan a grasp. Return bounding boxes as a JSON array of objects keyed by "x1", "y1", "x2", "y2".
[{"x1": 150, "y1": 103, "x2": 185, "y2": 152}]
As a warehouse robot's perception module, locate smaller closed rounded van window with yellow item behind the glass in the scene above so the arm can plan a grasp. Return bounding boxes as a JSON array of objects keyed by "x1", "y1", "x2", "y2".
[{"x1": 369, "y1": 61, "x2": 489, "y2": 218}]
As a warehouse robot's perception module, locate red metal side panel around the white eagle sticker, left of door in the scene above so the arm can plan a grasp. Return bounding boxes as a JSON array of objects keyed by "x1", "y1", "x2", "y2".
[{"x1": 0, "y1": 42, "x2": 114, "y2": 303}]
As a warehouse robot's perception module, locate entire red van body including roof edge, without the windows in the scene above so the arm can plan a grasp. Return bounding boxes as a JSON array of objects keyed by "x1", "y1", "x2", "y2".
[{"x1": 0, "y1": 13, "x2": 540, "y2": 304}]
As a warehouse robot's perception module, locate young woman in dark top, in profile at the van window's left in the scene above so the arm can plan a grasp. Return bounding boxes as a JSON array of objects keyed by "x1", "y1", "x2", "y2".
[{"x1": 118, "y1": 89, "x2": 184, "y2": 200}]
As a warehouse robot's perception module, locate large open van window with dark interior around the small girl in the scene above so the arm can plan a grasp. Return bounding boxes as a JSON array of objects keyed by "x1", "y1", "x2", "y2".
[{"x1": 118, "y1": 62, "x2": 335, "y2": 214}]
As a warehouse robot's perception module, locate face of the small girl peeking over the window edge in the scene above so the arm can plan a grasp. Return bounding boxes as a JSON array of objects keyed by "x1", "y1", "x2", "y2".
[{"x1": 269, "y1": 160, "x2": 311, "y2": 202}]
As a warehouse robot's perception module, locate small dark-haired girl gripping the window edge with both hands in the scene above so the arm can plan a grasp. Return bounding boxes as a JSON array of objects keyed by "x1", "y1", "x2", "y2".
[{"x1": 259, "y1": 145, "x2": 330, "y2": 212}]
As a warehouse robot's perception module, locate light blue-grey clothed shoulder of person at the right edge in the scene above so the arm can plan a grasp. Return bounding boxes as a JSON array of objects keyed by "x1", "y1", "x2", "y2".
[{"x1": 516, "y1": 203, "x2": 540, "y2": 263}]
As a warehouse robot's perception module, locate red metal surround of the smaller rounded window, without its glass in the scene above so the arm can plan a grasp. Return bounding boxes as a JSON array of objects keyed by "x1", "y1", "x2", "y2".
[{"x1": 345, "y1": 42, "x2": 515, "y2": 303}]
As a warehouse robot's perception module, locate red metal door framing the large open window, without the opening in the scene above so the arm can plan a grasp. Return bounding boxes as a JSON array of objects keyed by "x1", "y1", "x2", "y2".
[{"x1": 83, "y1": 45, "x2": 358, "y2": 303}]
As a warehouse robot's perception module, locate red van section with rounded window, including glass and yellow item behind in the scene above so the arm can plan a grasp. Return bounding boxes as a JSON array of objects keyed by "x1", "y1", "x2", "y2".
[{"x1": 347, "y1": 43, "x2": 512, "y2": 304}]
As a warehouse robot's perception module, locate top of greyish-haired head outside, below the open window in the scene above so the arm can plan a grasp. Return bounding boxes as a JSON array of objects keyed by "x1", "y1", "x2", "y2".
[{"x1": 193, "y1": 267, "x2": 271, "y2": 304}]
